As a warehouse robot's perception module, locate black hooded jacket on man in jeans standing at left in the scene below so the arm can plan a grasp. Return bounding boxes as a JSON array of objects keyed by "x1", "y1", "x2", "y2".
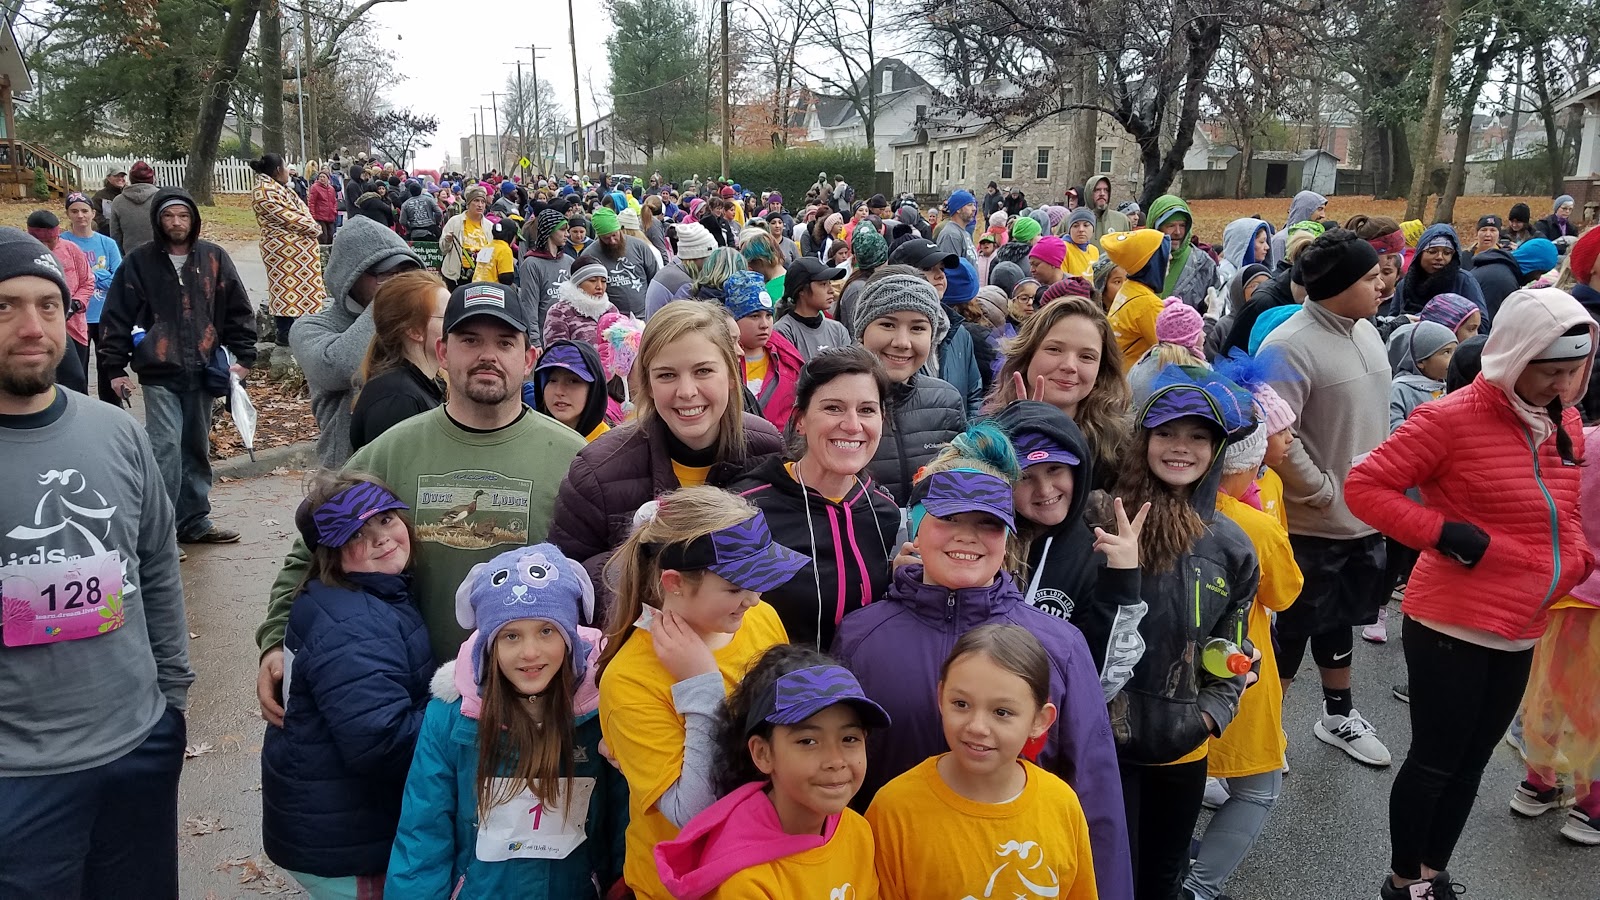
[{"x1": 99, "y1": 187, "x2": 256, "y2": 391}]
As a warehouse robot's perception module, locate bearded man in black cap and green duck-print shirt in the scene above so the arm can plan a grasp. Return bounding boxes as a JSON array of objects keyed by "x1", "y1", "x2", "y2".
[{"x1": 256, "y1": 282, "x2": 584, "y2": 727}]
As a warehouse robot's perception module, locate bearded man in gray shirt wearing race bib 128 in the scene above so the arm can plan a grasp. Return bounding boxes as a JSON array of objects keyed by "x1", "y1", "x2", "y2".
[{"x1": 0, "y1": 227, "x2": 194, "y2": 898}]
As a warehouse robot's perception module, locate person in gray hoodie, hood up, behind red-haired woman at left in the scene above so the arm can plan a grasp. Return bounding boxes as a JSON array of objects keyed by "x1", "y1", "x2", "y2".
[{"x1": 290, "y1": 216, "x2": 422, "y2": 469}]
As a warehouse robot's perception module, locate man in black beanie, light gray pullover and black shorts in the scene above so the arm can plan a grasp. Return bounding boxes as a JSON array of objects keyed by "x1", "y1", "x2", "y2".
[{"x1": 1261, "y1": 229, "x2": 1390, "y2": 765}]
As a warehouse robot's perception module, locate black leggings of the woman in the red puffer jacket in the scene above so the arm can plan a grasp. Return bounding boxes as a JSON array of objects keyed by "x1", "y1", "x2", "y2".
[{"x1": 1389, "y1": 617, "x2": 1533, "y2": 878}]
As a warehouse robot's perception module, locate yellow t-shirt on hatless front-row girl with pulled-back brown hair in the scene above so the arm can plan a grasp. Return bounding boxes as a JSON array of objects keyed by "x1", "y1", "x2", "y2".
[{"x1": 867, "y1": 756, "x2": 1099, "y2": 900}]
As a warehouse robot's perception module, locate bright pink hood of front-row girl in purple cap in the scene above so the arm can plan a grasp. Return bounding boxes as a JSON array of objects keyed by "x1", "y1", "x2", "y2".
[{"x1": 654, "y1": 781, "x2": 838, "y2": 900}]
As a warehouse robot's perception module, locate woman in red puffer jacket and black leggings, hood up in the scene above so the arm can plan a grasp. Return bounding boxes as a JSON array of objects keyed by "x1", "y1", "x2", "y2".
[{"x1": 1344, "y1": 288, "x2": 1597, "y2": 898}]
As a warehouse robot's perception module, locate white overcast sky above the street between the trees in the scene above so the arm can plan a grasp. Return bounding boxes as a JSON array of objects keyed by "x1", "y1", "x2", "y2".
[{"x1": 370, "y1": 0, "x2": 611, "y2": 168}]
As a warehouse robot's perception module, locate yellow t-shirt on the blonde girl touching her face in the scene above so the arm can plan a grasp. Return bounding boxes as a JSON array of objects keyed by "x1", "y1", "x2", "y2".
[{"x1": 600, "y1": 604, "x2": 789, "y2": 900}]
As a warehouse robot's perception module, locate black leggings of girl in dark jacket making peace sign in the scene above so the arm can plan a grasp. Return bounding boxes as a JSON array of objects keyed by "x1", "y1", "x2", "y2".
[{"x1": 1117, "y1": 759, "x2": 1206, "y2": 900}]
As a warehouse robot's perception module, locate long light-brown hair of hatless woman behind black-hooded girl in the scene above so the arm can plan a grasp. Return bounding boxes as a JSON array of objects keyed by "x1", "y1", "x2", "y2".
[{"x1": 984, "y1": 296, "x2": 1133, "y2": 472}]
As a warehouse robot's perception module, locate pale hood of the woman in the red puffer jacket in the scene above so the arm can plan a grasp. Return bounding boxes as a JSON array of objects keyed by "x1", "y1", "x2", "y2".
[{"x1": 1483, "y1": 288, "x2": 1597, "y2": 444}]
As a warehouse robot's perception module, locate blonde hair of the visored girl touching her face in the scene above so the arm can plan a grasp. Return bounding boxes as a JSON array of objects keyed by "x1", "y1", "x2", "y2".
[{"x1": 595, "y1": 483, "x2": 755, "y2": 682}]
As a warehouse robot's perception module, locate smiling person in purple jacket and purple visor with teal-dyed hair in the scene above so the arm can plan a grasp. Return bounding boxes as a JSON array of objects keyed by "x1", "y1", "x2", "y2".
[{"x1": 834, "y1": 423, "x2": 1133, "y2": 900}]
